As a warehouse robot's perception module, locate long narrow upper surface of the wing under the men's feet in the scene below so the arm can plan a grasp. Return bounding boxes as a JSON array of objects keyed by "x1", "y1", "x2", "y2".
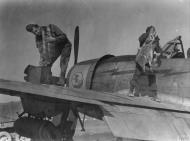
[{"x1": 0, "y1": 79, "x2": 190, "y2": 113}]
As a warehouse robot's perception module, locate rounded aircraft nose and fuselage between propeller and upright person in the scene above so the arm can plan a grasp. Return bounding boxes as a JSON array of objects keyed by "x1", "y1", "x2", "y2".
[{"x1": 67, "y1": 55, "x2": 135, "y2": 92}]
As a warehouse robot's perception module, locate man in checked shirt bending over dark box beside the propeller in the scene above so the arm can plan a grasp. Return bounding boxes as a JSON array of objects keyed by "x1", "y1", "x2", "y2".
[{"x1": 26, "y1": 24, "x2": 72, "y2": 85}]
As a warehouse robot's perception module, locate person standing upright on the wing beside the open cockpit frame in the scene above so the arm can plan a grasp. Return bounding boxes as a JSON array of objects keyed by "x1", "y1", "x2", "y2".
[{"x1": 129, "y1": 26, "x2": 161, "y2": 101}]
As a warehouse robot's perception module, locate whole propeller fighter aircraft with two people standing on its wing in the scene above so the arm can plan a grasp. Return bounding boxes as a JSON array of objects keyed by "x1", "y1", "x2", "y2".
[{"x1": 0, "y1": 27, "x2": 190, "y2": 141}]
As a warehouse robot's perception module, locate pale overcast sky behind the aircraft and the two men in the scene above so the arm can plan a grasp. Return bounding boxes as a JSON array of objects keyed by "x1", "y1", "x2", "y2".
[{"x1": 0, "y1": 0, "x2": 190, "y2": 102}]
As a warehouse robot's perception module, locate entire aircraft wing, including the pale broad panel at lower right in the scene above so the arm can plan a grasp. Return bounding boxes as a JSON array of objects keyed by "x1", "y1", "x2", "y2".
[{"x1": 0, "y1": 79, "x2": 190, "y2": 141}]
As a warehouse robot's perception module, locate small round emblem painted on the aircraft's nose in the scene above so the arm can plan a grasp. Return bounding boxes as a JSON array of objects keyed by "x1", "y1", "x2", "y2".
[{"x1": 71, "y1": 72, "x2": 83, "y2": 88}]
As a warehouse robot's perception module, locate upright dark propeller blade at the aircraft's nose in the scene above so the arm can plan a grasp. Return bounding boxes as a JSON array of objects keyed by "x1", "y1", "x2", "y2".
[{"x1": 74, "y1": 26, "x2": 79, "y2": 65}]
